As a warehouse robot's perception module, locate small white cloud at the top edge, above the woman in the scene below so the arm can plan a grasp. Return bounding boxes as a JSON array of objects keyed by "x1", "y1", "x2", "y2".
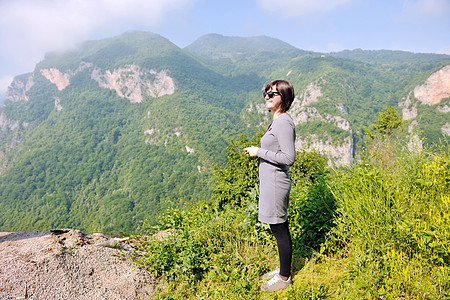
[{"x1": 257, "y1": 0, "x2": 355, "y2": 18}]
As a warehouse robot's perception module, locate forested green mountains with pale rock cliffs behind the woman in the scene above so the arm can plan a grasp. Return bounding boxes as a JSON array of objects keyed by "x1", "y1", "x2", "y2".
[{"x1": 0, "y1": 31, "x2": 450, "y2": 233}]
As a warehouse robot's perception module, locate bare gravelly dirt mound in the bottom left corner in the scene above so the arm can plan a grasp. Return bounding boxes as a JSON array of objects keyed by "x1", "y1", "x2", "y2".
[{"x1": 0, "y1": 229, "x2": 156, "y2": 300}]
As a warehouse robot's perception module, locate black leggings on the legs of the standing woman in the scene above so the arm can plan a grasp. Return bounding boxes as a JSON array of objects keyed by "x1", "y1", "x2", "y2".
[{"x1": 270, "y1": 221, "x2": 292, "y2": 277}]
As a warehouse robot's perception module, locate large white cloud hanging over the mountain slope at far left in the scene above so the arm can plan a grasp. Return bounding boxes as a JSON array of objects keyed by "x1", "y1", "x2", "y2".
[{"x1": 0, "y1": 0, "x2": 198, "y2": 76}]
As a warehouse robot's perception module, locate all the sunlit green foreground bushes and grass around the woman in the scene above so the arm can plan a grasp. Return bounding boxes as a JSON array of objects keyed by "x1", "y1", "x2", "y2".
[{"x1": 125, "y1": 109, "x2": 450, "y2": 299}]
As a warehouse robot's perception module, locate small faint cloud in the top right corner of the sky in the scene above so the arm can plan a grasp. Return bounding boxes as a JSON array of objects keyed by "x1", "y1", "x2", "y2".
[{"x1": 401, "y1": 0, "x2": 450, "y2": 19}]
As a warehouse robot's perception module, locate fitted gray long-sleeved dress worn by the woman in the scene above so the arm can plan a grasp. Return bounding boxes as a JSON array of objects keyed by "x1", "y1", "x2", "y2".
[{"x1": 256, "y1": 114, "x2": 295, "y2": 224}]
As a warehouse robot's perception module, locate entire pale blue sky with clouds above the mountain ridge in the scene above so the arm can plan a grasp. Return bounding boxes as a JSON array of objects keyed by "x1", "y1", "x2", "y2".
[{"x1": 0, "y1": 0, "x2": 450, "y2": 93}]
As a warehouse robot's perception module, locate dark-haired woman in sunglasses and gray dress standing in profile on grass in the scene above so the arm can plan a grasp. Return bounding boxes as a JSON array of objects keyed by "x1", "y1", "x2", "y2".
[{"x1": 244, "y1": 80, "x2": 295, "y2": 292}]
